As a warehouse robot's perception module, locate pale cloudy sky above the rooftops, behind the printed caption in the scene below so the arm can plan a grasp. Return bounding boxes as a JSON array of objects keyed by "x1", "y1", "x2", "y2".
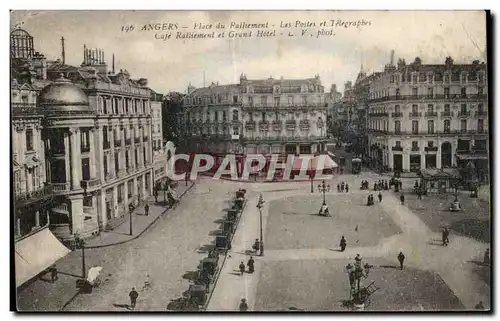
[{"x1": 11, "y1": 11, "x2": 486, "y2": 93}]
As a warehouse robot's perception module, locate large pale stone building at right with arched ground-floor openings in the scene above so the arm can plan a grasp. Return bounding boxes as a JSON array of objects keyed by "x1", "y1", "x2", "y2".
[{"x1": 368, "y1": 57, "x2": 488, "y2": 178}]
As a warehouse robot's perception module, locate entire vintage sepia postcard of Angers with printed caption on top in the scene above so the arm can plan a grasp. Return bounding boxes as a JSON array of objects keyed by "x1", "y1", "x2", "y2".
[{"x1": 10, "y1": 10, "x2": 492, "y2": 313}]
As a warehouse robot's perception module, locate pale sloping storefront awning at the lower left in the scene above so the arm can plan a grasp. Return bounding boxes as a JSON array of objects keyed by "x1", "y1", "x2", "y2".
[{"x1": 15, "y1": 227, "x2": 70, "y2": 287}]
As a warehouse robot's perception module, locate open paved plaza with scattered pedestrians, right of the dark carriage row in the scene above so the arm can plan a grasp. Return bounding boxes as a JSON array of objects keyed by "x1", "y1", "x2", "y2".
[{"x1": 208, "y1": 173, "x2": 490, "y2": 311}]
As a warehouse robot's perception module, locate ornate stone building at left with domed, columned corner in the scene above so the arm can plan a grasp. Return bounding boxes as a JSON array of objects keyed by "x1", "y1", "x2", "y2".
[{"x1": 11, "y1": 29, "x2": 157, "y2": 240}]
